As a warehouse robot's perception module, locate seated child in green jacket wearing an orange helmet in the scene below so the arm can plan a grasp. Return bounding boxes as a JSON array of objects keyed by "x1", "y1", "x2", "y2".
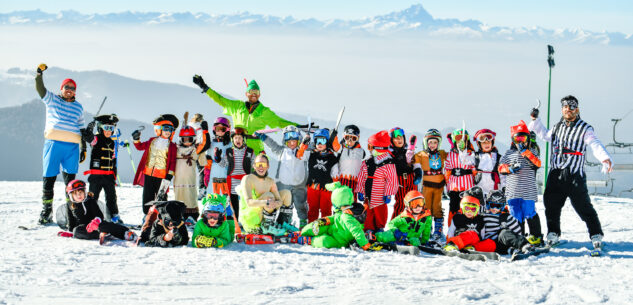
[{"x1": 376, "y1": 190, "x2": 432, "y2": 246}]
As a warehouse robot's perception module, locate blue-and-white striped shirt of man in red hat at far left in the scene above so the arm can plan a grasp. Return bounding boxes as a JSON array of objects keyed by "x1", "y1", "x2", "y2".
[{"x1": 42, "y1": 90, "x2": 84, "y2": 135}]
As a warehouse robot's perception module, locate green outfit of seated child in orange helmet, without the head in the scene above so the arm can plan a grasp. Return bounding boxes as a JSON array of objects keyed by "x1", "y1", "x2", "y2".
[{"x1": 376, "y1": 210, "x2": 432, "y2": 246}]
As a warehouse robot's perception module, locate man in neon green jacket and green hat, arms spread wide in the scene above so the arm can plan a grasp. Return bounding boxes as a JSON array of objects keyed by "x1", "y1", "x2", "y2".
[{"x1": 193, "y1": 75, "x2": 297, "y2": 155}]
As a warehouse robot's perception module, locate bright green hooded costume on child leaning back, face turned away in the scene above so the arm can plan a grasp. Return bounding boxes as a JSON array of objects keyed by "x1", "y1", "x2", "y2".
[{"x1": 301, "y1": 182, "x2": 369, "y2": 249}]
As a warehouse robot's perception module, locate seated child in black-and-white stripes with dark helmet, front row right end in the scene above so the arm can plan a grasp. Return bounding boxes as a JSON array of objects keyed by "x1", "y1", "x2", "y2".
[{"x1": 484, "y1": 190, "x2": 534, "y2": 254}]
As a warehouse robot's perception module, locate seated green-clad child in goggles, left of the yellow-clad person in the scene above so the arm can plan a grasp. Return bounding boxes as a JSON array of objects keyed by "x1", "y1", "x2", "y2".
[{"x1": 191, "y1": 194, "x2": 235, "y2": 248}]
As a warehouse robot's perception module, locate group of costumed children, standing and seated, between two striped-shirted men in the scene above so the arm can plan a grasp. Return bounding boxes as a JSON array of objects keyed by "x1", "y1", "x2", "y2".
[{"x1": 66, "y1": 103, "x2": 542, "y2": 253}]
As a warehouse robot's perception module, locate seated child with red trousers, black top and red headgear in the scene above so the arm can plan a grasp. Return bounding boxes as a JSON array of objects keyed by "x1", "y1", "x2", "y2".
[{"x1": 444, "y1": 190, "x2": 496, "y2": 252}]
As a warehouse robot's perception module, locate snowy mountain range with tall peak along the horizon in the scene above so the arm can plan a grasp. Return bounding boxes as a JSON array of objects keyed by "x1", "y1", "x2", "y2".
[{"x1": 0, "y1": 4, "x2": 633, "y2": 46}]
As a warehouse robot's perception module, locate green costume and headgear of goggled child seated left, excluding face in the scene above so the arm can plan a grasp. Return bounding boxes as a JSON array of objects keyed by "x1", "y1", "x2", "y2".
[{"x1": 191, "y1": 194, "x2": 235, "y2": 248}]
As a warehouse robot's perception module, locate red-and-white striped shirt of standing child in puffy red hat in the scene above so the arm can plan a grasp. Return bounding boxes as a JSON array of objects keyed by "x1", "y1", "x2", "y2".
[{"x1": 355, "y1": 154, "x2": 399, "y2": 208}]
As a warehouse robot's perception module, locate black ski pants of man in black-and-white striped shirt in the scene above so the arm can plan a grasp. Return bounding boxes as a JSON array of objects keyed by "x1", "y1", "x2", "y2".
[{"x1": 543, "y1": 169, "x2": 603, "y2": 237}]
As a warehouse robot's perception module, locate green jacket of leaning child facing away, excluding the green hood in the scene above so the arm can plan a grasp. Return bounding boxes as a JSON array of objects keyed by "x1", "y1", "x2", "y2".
[{"x1": 301, "y1": 212, "x2": 369, "y2": 248}]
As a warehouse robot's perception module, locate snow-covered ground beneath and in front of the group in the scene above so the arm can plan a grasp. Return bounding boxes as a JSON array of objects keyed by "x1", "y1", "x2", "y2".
[{"x1": 0, "y1": 182, "x2": 633, "y2": 304}]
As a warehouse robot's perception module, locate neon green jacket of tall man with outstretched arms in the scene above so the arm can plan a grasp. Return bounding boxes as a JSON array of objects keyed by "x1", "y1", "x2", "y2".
[{"x1": 207, "y1": 88, "x2": 297, "y2": 155}]
